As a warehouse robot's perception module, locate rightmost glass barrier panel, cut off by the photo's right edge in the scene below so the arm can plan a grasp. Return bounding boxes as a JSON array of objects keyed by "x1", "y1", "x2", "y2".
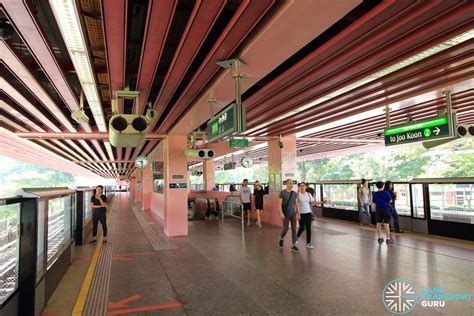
[{"x1": 429, "y1": 183, "x2": 474, "y2": 224}]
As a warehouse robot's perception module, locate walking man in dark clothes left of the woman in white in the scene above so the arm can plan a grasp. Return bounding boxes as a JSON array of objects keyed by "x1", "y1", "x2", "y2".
[{"x1": 278, "y1": 179, "x2": 300, "y2": 252}]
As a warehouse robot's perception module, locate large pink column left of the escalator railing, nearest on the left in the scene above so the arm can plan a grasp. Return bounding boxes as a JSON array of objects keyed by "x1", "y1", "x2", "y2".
[{"x1": 163, "y1": 135, "x2": 188, "y2": 236}]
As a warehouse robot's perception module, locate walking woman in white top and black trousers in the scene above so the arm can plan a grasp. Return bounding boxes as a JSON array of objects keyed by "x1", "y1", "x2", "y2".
[{"x1": 296, "y1": 182, "x2": 323, "y2": 249}]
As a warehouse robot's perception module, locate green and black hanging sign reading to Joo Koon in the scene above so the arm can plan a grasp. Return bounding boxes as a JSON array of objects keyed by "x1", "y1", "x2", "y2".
[{"x1": 384, "y1": 117, "x2": 451, "y2": 146}]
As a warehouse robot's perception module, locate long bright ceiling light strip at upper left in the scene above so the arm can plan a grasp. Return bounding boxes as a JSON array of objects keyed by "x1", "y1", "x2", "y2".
[{"x1": 49, "y1": 0, "x2": 107, "y2": 132}]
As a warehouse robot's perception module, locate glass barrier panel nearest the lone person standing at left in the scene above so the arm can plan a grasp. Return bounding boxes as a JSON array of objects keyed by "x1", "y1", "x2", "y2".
[{"x1": 47, "y1": 196, "x2": 71, "y2": 269}]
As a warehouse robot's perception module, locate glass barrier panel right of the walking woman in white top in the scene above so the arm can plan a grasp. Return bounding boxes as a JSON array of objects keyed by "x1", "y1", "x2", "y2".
[{"x1": 323, "y1": 184, "x2": 357, "y2": 211}]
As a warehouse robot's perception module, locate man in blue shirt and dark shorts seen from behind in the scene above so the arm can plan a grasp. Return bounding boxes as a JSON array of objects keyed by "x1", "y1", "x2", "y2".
[{"x1": 372, "y1": 181, "x2": 393, "y2": 244}]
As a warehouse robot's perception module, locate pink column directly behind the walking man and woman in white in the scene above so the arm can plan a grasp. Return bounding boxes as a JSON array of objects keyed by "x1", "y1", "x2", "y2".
[{"x1": 264, "y1": 134, "x2": 297, "y2": 226}]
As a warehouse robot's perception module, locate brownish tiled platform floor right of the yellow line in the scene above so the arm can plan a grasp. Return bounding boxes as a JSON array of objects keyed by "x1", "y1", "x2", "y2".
[{"x1": 46, "y1": 193, "x2": 474, "y2": 315}]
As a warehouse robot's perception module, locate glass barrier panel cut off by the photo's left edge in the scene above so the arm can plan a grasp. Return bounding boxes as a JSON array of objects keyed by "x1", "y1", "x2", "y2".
[{"x1": 0, "y1": 203, "x2": 21, "y2": 304}]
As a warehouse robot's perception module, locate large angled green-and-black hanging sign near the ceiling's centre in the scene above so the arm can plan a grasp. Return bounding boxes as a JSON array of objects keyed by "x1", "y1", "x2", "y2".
[{"x1": 207, "y1": 104, "x2": 238, "y2": 142}]
